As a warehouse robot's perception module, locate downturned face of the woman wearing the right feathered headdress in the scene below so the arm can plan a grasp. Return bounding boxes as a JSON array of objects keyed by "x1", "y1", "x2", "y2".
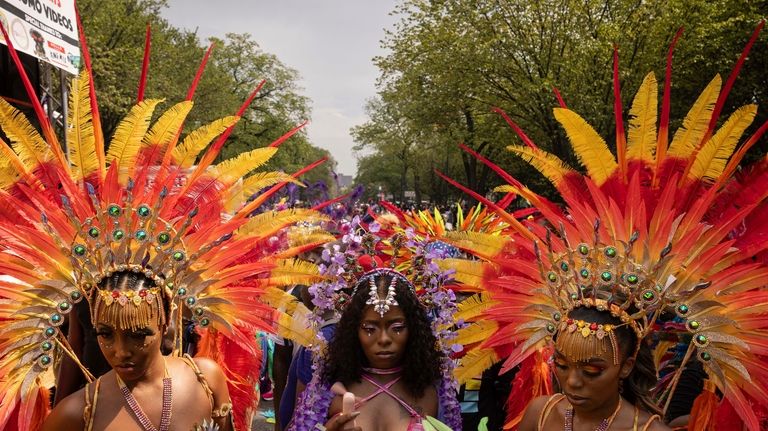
[{"x1": 554, "y1": 350, "x2": 634, "y2": 411}]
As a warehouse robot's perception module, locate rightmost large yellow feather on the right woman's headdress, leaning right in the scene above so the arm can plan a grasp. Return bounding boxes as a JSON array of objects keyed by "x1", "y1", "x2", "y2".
[{"x1": 688, "y1": 105, "x2": 757, "y2": 182}]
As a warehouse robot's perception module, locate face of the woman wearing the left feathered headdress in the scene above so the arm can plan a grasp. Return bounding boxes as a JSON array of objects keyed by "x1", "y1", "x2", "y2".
[{"x1": 95, "y1": 319, "x2": 163, "y2": 381}]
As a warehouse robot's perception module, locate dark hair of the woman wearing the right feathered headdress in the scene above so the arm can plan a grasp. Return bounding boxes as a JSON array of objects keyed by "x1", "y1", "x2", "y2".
[{"x1": 568, "y1": 307, "x2": 661, "y2": 414}]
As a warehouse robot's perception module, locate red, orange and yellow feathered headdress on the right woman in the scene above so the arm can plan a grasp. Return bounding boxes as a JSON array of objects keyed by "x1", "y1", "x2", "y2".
[{"x1": 446, "y1": 23, "x2": 768, "y2": 430}]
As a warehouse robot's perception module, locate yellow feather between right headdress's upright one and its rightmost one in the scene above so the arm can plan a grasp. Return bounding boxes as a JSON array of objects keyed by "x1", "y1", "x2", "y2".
[{"x1": 669, "y1": 75, "x2": 722, "y2": 159}]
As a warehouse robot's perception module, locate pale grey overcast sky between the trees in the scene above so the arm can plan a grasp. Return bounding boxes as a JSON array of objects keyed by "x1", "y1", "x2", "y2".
[{"x1": 163, "y1": 0, "x2": 397, "y2": 175}]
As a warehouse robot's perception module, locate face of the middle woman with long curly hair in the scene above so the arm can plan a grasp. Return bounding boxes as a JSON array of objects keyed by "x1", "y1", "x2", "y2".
[{"x1": 357, "y1": 305, "x2": 408, "y2": 368}]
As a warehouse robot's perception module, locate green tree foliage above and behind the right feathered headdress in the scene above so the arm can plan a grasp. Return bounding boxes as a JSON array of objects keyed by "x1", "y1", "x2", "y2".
[{"x1": 353, "y1": 0, "x2": 768, "y2": 202}]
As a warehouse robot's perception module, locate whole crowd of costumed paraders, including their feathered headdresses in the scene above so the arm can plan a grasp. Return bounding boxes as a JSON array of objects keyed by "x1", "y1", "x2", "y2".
[{"x1": 0, "y1": 12, "x2": 768, "y2": 431}]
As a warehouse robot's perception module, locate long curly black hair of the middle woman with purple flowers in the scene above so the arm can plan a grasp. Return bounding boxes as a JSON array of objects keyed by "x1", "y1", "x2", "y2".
[{"x1": 322, "y1": 274, "x2": 444, "y2": 398}]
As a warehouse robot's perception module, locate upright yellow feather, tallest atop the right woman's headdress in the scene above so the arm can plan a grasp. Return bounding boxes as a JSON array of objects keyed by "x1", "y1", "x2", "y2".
[{"x1": 627, "y1": 72, "x2": 659, "y2": 163}]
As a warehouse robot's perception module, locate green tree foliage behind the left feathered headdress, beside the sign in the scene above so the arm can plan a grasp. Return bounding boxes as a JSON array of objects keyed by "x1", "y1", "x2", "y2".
[{"x1": 78, "y1": 0, "x2": 334, "y2": 186}]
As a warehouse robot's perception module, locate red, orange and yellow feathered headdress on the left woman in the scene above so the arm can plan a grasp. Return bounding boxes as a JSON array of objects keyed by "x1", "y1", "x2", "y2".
[{"x1": 0, "y1": 21, "x2": 327, "y2": 429}]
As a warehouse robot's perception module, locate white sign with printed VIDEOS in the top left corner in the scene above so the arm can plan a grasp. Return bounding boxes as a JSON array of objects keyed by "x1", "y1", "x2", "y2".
[{"x1": 0, "y1": 0, "x2": 80, "y2": 74}]
